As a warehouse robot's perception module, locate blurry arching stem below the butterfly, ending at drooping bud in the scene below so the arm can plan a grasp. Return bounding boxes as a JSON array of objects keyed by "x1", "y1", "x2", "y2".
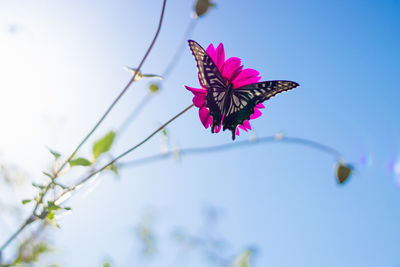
[{"x1": 119, "y1": 136, "x2": 342, "y2": 168}]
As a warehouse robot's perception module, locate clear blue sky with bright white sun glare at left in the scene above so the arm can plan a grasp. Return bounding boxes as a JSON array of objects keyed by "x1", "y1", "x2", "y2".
[{"x1": 0, "y1": 0, "x2": 400, "y2": 266}]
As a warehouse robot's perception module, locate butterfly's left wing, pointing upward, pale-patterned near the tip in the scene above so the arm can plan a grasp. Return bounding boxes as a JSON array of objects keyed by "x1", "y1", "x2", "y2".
[{"x1": 188, "y1": 40, "x2": 228, "y2": 132}]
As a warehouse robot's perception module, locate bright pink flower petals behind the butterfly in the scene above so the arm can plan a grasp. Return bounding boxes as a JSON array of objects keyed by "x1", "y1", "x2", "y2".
[{"x1": 185, "y1": 43, "x2": 265, "y2": 138}]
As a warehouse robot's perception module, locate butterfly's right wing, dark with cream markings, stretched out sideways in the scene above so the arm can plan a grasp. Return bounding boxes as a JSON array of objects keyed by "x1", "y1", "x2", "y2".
[{"x1": 222, "y1": 81, "x2": 299, "y2": 140}]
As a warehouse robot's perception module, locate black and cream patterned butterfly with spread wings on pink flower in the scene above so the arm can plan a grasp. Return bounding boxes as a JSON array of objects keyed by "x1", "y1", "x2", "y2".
[{"x1": 188, "y1": 40, "x2": 299, "y2": 140}]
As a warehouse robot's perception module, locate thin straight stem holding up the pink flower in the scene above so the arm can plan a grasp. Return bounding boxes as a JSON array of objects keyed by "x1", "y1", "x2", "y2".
[{"x1": 56, "y1": 104, "x2": 194, "y2": 205}]
